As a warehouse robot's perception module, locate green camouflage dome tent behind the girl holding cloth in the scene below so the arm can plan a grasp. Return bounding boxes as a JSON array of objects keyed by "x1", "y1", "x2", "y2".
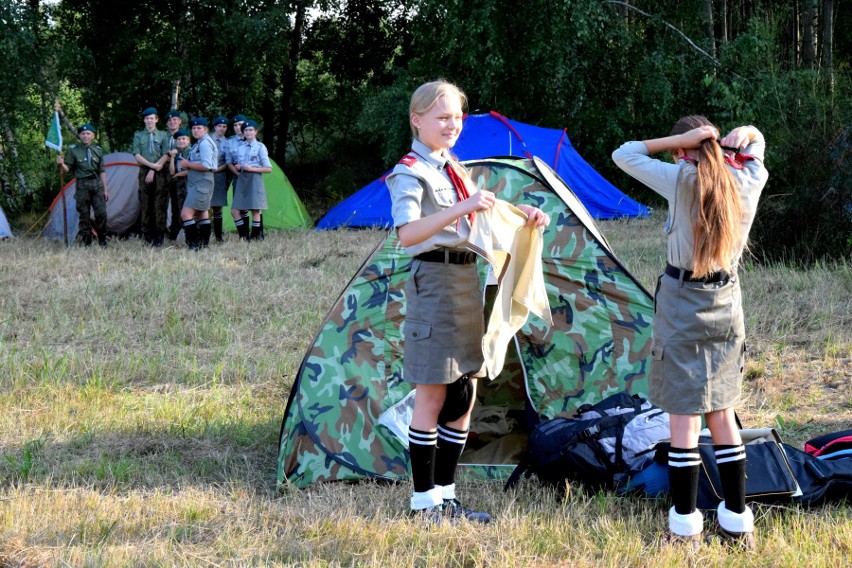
[{"x1": 278, "y1": 158, "x2": 653, "y2": 487}]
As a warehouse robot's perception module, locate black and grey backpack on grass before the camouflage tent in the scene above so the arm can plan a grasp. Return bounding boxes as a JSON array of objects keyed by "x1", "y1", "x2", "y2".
[{"x1": 505, "y1": 392, "x2": 669, "y2": 490}]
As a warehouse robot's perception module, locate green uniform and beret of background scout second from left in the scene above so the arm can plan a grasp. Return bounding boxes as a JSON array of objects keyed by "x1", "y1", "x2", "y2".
[{"x1": 131, "y1": 107, "x2": 169, "y2": 246}]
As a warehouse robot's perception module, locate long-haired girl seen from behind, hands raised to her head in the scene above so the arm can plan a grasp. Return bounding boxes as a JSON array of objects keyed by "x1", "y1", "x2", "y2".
[{"x1": 612, "y1": 116, "x2": 768, "y2": 549}]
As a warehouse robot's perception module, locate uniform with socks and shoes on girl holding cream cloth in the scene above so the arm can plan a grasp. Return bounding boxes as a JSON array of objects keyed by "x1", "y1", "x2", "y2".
[{"x1": 387, "y1": 139, "x2": 491, "y2": 523}]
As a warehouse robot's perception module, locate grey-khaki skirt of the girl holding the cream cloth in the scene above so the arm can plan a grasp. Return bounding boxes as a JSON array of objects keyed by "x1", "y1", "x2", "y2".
[{"x1": 403, "y1": 259, "x2": 485, "y2": 384}]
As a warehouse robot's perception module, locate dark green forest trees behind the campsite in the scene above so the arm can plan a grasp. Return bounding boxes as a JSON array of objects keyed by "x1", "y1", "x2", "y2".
[{"x1": 0, "y1": 0, "x2": 852, "y2": 264}]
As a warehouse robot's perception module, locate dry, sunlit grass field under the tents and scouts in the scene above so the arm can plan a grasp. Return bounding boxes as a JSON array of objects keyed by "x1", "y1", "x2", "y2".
[{"x1": 0, "y1": 215, "x2": 852, "y2": 567}]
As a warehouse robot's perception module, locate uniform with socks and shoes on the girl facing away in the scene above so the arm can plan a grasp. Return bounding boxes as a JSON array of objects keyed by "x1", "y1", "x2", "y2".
[{"x1": 612, "y1": 129, "x2": 769, "y2": 549}]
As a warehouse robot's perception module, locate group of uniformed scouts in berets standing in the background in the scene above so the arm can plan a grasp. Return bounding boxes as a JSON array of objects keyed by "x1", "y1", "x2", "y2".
[{"x1": 57, "y1": 107, "x2": 272, "y2": 250}]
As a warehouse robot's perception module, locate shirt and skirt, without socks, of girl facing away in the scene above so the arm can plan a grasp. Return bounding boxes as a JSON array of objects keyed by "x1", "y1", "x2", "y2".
[{"x1": 613, "y1": 136, "x2": 769, "y2": 414}]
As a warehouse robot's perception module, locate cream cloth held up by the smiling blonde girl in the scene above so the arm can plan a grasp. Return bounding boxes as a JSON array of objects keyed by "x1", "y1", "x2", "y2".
[{"x1": 467, "y1": 199, "x2": 553, "y2": 379}]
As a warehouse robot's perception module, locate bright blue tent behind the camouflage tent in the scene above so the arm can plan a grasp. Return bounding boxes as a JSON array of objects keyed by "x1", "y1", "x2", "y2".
[{"x1": 317, "y1": 111, "x2": 650, "y2": 229}]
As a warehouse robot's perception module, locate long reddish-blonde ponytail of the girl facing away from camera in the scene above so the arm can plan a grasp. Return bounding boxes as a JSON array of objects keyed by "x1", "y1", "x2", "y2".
[{"x1": 672, "y1": 116, "x2": 745, "y2": 278}]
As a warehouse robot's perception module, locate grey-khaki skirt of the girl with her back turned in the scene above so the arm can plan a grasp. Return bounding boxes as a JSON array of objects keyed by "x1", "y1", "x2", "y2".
[{"x1": 648, "y1": 274, "x2": 745, "y2": 414}]
